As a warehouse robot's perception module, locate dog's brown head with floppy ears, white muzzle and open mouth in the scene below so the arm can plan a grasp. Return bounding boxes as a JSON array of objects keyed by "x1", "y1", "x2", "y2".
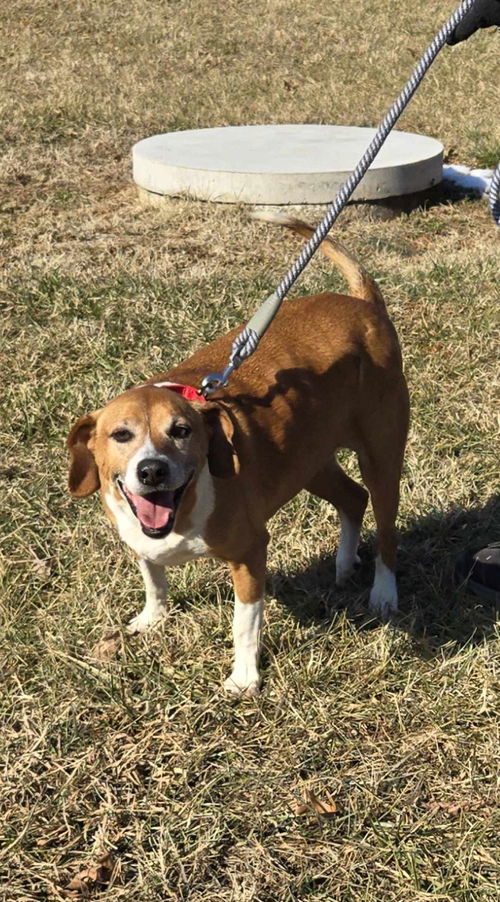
[{"x1": 67, "y1": 385, "x2": 237, "y2": 538}]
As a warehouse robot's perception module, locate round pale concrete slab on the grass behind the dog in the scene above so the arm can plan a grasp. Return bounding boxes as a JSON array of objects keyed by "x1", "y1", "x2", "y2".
[{"x1": 132, "y1": 125, "x2": 443, "y2": 204}]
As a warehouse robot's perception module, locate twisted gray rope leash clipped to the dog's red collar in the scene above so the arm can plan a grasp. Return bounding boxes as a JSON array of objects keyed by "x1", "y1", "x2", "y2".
[{"x1": 201, "y1": 0, "x2": 480, "y2": 398}]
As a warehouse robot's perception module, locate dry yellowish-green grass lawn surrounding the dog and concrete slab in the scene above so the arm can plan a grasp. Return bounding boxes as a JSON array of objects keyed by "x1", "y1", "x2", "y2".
[{"x1": 0, "y1": 0, "x2": 500, "y2": 902}]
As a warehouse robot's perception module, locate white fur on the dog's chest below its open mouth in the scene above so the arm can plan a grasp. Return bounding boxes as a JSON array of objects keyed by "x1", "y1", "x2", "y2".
[{"x1": 105, "y1": 464, "x2": 215, "y2": 567}]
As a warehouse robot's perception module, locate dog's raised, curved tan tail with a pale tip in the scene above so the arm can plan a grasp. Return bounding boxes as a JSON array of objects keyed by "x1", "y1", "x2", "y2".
[{"x1": 250, "y1": 211, "x2": 385, "y2": 310}]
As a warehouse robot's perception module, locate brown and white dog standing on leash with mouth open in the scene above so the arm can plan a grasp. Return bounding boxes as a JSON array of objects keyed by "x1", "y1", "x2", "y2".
[{"x1": 68, "y1": 216, "x2": 408, "y2": 695}]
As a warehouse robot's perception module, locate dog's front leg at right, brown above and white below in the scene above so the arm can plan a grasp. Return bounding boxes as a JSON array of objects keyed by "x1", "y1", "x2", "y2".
[{"x1": 224, "y1": 538, "x2": 267, "y2": 695}]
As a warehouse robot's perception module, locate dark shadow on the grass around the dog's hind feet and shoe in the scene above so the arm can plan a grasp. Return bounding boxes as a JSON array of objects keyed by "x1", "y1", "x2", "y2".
[{"x1": 269, "y1": 494, "x2": 500, "y2": 656}]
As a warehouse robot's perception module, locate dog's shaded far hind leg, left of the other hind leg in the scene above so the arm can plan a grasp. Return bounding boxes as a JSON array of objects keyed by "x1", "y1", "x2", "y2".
[{"x1": 306, "y1": 460, "x2": 368, "y2": 586}]
